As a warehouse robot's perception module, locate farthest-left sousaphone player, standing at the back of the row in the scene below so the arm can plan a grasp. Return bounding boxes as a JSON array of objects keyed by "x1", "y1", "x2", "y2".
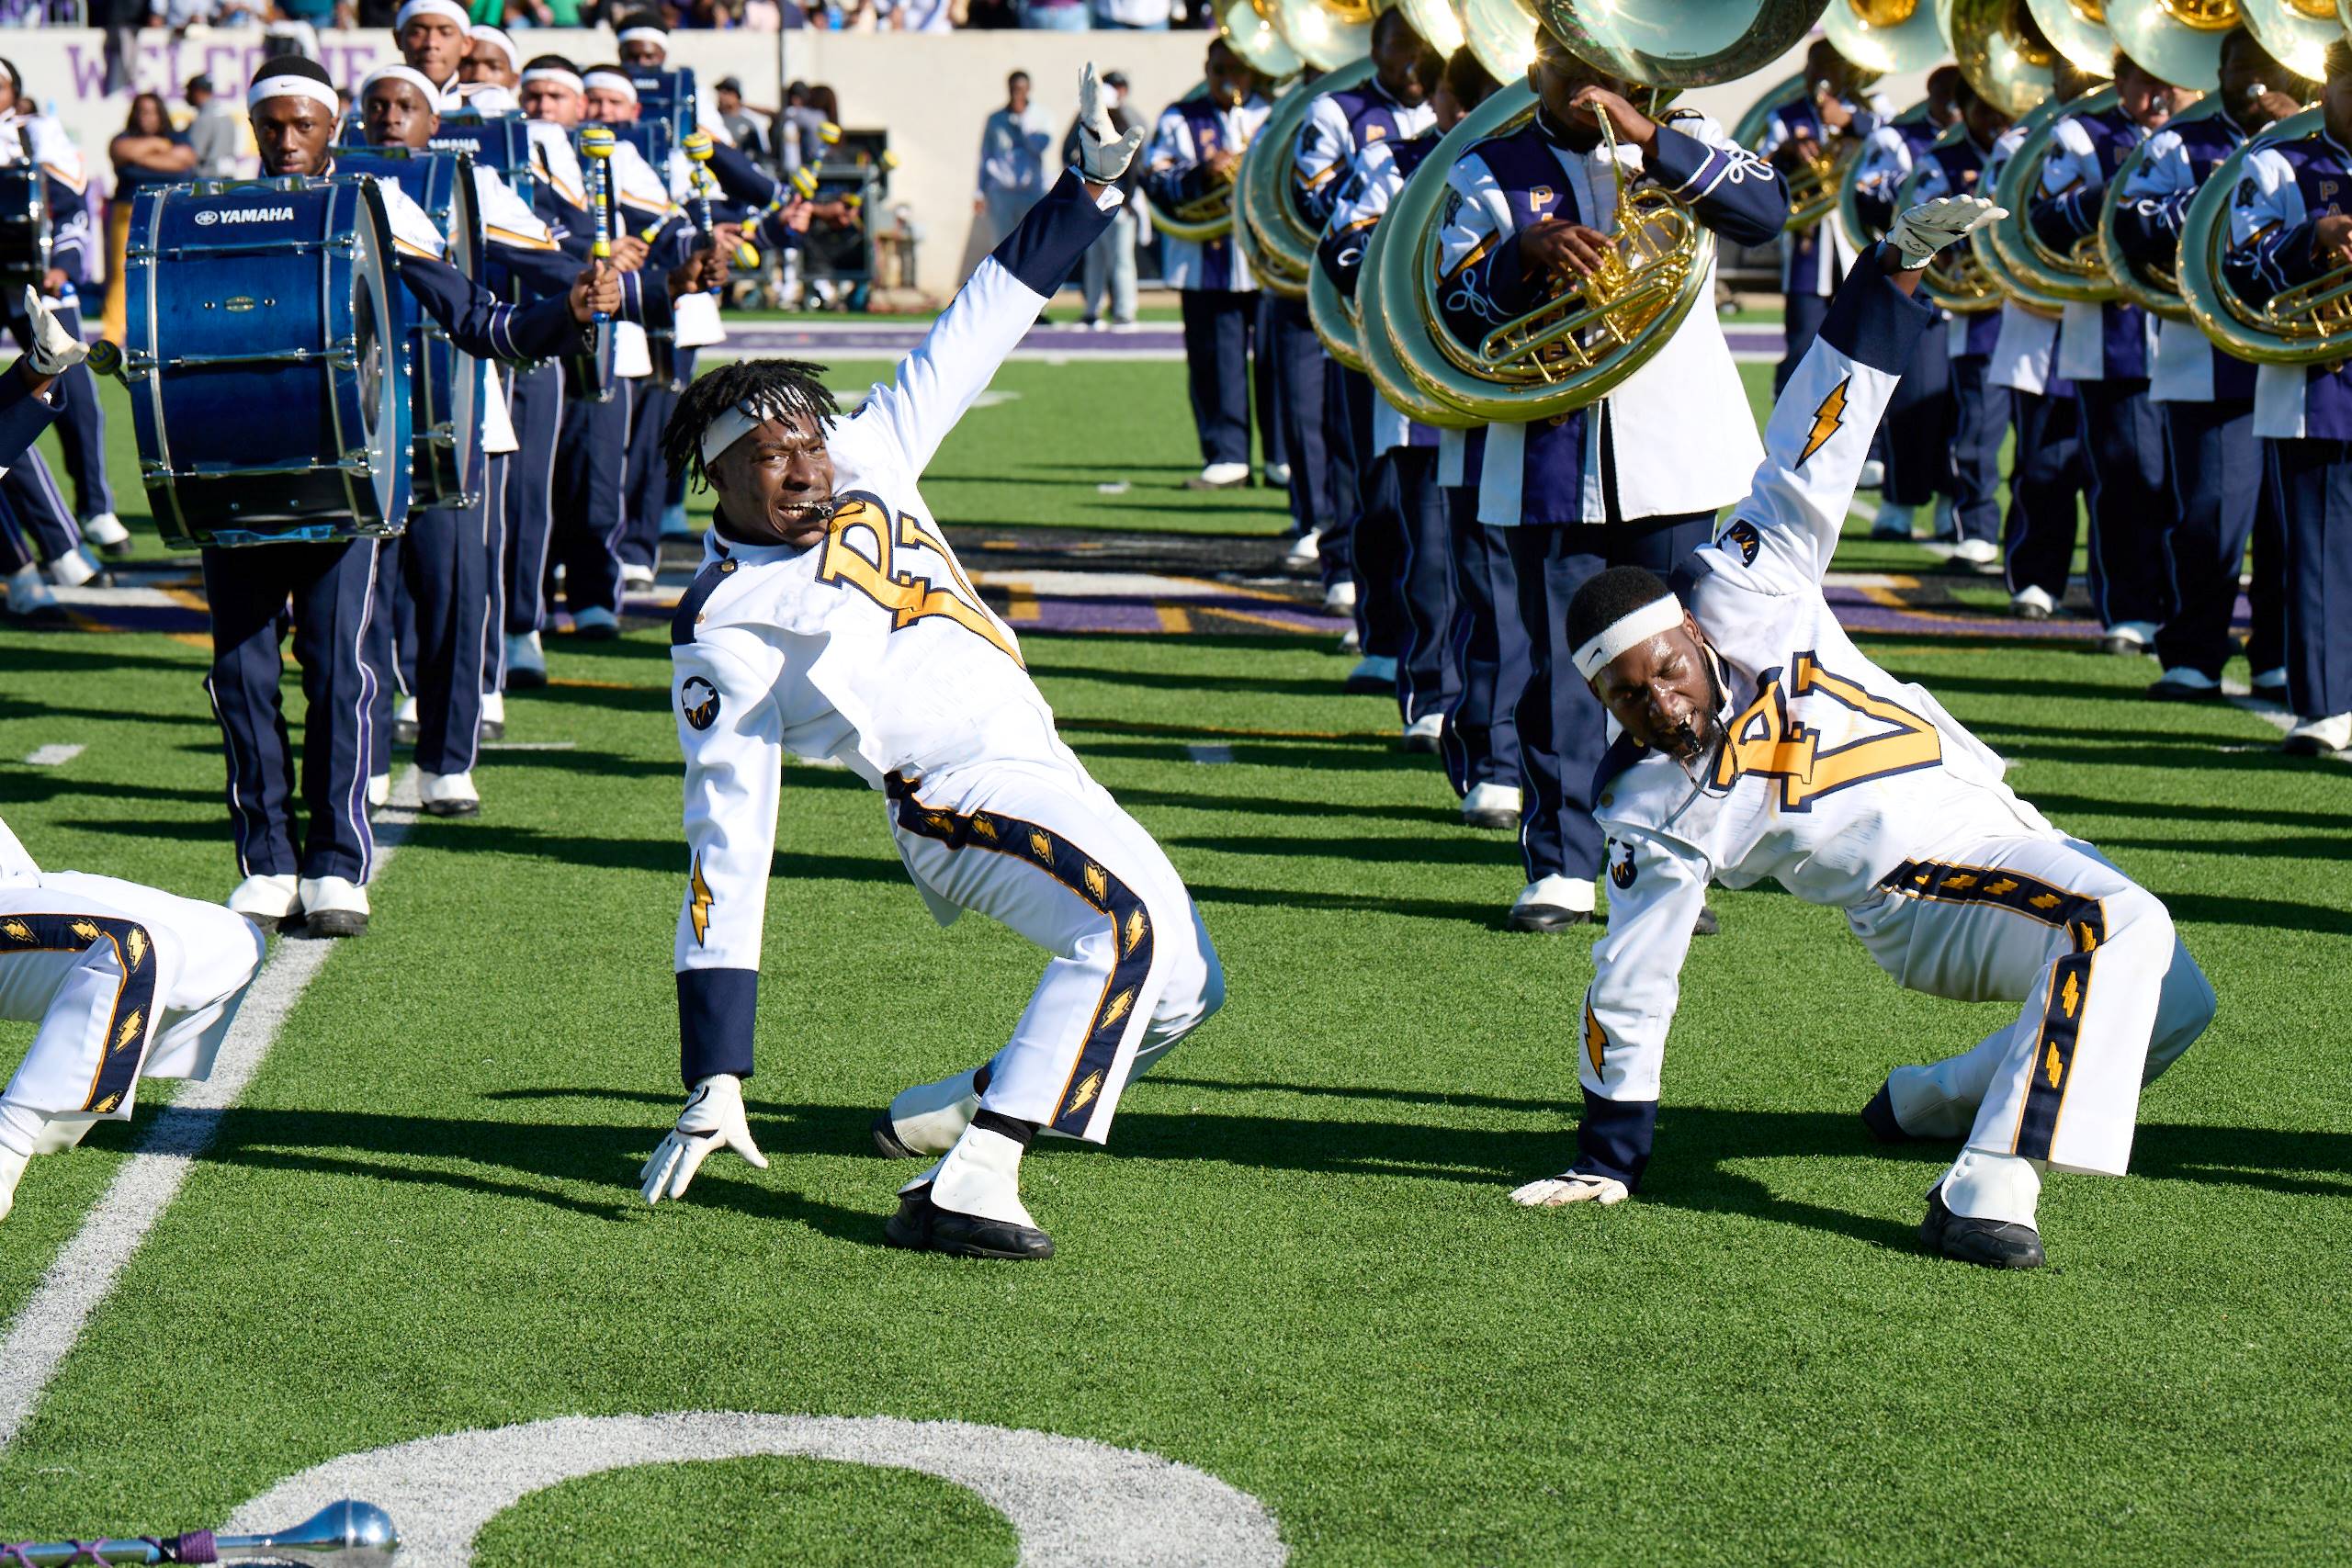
[{"x1": 1143, "y1": 38, "x2": 1268, "y2": 489}]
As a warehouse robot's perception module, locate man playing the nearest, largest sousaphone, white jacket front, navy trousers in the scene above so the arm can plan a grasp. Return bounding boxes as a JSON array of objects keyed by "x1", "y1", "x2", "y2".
[{"x1": 1437, "y1": 30, "x2": 1788, "y2": 931}]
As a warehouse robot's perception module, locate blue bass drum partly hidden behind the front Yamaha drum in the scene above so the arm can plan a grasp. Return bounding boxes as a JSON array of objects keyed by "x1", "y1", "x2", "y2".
[{"x1": 334, "y1": 148, "x2": 484, "y2": 508}]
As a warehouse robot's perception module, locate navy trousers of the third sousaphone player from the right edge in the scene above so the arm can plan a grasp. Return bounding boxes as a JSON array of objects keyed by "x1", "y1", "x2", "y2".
[{"x1": 2075, "y1": 381, "x2": 2173, "y2": 626}]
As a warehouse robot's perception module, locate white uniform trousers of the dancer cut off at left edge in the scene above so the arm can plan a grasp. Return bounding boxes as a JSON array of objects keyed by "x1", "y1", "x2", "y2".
[{"x1": 0, "y1": 872, "x2": 264, "y2": 1155}]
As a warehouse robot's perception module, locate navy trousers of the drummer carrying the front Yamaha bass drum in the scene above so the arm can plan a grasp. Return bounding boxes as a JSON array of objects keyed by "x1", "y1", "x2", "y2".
[{"x1": 202, "y1": 541, "x2": 377, "y2": 882}]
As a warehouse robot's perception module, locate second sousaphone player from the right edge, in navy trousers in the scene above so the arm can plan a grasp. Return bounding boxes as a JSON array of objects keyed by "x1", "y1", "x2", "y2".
[{"x1": 2114, "y1": 28, "x2": 2317, "y2": 701}]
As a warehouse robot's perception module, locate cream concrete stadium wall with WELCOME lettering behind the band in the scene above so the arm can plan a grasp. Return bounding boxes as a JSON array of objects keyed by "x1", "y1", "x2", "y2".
[{"x1": 0, "y1": 28, "x2": 1919, "y2": 294}]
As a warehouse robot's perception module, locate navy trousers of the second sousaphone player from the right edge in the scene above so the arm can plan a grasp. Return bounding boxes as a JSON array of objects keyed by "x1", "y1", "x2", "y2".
[{"x1": 2157, "y1": 398, "x2": 2281, "y2": 680}]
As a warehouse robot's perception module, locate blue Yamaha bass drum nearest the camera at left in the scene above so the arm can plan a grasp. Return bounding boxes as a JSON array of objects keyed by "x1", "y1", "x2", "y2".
[{"x1": 120, "y1": 179, "x2": 409, "y2": 547}]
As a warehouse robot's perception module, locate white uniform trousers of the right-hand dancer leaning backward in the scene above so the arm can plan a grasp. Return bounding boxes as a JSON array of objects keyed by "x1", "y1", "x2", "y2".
[{"x1": 1847, "y1": 837, "x2": 2213, "y2": 1176}]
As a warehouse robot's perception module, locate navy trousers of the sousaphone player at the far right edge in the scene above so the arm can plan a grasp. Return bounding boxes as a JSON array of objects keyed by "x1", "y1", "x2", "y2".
[{"x1": 2263, "y1": 440, "x2": 2352, "y2": 719}]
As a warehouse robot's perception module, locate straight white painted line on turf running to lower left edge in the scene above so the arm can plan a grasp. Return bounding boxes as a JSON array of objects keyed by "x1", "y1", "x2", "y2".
[{"x1": 0, "y1": 766, "x2": 419, "y2": 1450}]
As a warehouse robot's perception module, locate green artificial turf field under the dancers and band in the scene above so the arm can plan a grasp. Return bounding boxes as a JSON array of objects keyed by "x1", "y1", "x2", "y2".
[{"x1": 0, "y1": 365, "x2": 2352, "y2": 1565}]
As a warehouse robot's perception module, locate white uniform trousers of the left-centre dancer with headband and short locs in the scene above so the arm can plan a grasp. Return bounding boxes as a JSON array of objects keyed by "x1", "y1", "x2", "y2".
[{"x1": 889, "y1": 736, "x2": 1226, "y2": 1143}]
